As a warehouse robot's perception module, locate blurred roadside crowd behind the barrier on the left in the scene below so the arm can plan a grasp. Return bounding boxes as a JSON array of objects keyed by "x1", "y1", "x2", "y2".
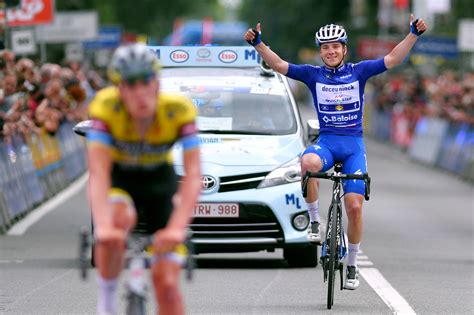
[{"x1": 0, "y1": 50, "x2": 106, "y2": 153}]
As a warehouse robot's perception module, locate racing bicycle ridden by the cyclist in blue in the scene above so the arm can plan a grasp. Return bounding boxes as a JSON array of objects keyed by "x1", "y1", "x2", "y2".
[{"x1": 302, "y1": 162, "x2": 370, "y2": 309}]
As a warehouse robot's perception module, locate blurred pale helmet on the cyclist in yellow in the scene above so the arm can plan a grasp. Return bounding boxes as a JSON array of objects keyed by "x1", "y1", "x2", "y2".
[{"x1": 107, "y1": 43, "x2": 160, "y2": 83}]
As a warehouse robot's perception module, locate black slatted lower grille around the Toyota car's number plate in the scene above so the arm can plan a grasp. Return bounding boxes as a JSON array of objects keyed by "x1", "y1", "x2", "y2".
[{"x1": 189, "y1": 204, "x2": 283, "y2": 242}]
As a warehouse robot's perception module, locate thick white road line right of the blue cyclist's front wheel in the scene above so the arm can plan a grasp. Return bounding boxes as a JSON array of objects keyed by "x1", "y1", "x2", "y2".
[{"x1": 359, "y1": 268, "x2": 416, "y2": 314}]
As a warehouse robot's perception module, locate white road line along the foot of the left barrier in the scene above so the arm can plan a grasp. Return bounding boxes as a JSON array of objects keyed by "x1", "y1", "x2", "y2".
[{"x1": 7, "y1": 173, "x2": 88, "y2": 235}]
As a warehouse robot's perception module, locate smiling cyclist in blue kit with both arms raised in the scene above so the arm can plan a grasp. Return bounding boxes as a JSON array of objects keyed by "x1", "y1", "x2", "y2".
[{"x1": 244, "y1": 14, "x2": 427, "y2": 290}]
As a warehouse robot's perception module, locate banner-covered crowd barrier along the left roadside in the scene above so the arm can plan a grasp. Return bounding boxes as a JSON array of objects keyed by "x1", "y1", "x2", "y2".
[{"x1": 0, "y1": 122, "x2": 86, "y2": 233}]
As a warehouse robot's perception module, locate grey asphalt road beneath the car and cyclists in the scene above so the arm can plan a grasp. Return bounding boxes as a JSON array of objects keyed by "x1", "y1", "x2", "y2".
[{"x1": 0, "y1": 106, "x2": 474, "y2": 315}]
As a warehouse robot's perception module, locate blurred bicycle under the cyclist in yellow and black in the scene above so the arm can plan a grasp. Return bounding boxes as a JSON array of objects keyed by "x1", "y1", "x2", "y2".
[{"x1": 79, "y1": 228, "x2": 194, "y2": 315}]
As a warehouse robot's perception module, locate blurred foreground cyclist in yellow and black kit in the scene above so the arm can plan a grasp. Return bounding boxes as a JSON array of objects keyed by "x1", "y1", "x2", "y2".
[{"x1": 87, "y1": 44, "x2": 201, "y2": 314}]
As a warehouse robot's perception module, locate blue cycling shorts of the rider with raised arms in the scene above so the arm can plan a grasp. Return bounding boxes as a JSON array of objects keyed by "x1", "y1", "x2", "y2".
[{"x1": 303, "y1": 135, "x2": 367, "y2": 195}]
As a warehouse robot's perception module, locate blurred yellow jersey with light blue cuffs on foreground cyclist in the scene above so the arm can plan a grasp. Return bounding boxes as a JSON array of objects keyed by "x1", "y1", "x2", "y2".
[{"x1": 87, "y1": 87, "x2": 199, "y2": 168}]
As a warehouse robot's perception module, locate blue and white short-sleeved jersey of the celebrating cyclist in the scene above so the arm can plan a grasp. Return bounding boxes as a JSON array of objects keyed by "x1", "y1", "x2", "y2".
[{"x1": 286, "y1": 58, "x2": 387, "y2": 137}]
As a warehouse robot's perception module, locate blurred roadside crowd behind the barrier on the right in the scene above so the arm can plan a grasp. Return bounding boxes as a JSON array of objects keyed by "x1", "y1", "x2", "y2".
[{"x1": 369, "y1": 70, "x2": 474, "y2": 149}]
